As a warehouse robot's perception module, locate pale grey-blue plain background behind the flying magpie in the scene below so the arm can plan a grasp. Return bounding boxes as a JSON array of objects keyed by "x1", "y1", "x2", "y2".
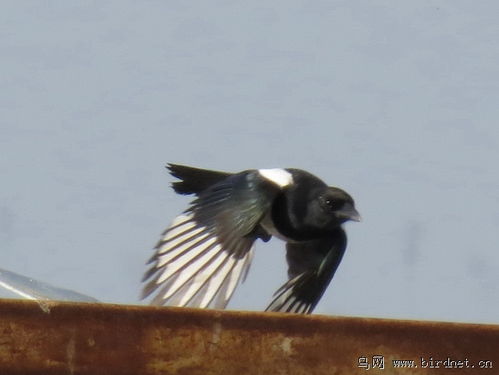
[{"x1": 0, "y1": 0, "x2": 499, "y2": 323}]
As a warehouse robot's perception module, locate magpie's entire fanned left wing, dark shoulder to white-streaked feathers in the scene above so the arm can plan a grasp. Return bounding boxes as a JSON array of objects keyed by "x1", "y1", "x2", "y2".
[{"x1": 142, "y1": 170, "x2": 279, "y2": 308}]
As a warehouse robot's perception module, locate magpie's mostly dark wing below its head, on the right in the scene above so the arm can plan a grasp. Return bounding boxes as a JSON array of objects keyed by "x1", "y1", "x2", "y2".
[{"x1": 266, "y1": 228, "x2": 347, "y2": 314}]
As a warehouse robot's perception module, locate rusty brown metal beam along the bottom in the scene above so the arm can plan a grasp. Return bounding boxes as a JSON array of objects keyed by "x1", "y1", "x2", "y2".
[{"x1": 0, "y1": 300, "x2": 499, "y2": 375}]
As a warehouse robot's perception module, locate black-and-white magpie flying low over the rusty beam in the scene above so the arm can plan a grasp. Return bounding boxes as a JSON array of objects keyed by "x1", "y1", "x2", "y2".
[{"x1": 141, "y1": 163, "x2": 361, "y2": 314}]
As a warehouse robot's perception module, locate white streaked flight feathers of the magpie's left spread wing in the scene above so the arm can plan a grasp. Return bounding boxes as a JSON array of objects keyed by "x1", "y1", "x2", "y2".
[{"x1": 144, "y1": 213, "x2": 253, "y2": 309}]
